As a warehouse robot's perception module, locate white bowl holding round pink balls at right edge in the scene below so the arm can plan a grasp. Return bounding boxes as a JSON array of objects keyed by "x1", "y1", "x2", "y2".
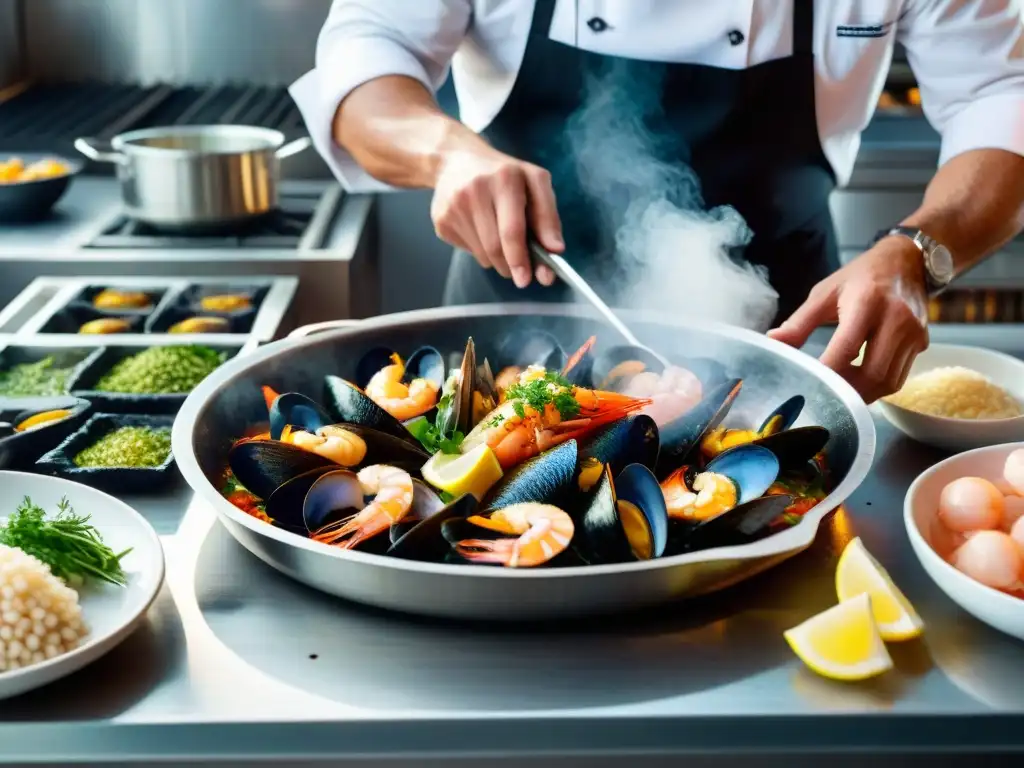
[{"x1": 903, "y1": 442, "x2": 1024, "y2": 640}]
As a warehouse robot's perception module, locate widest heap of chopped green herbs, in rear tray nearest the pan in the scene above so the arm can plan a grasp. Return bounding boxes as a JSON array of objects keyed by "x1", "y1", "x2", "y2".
[{"x1": 95, "y1": 345, "x2": 227, "y2": 394}]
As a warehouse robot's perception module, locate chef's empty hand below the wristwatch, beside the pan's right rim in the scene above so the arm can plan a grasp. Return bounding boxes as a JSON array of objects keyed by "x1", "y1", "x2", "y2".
[{"x1": 768, "y1": 237, "x2": 928, "y2": 403}]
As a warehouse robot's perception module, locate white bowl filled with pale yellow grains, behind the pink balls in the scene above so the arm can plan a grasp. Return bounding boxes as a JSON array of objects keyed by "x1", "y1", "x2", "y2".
[{"x1": 878, "y1": 344, "x2": 1024, "y2": 452}]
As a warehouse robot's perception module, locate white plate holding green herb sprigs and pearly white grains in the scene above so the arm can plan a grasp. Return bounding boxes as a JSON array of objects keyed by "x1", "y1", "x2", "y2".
[{"x1": 0, "y1": 472, "x2": 164, "y2": 698}]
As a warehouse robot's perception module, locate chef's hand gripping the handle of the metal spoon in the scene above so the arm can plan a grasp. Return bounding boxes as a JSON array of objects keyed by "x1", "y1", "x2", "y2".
[{"x1": 430, "y1": 145, "x2": 564, "y2": 288}]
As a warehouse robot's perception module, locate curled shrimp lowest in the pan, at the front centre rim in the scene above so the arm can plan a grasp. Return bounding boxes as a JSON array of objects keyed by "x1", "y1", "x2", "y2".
[{"x1": 456, "y1": 503, "x2": 575, "y2": 568}]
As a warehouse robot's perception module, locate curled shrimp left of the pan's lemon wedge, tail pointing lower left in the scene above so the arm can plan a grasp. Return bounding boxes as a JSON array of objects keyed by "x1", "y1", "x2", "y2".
[{"x1": 311, "y1": 464, "x2": 413, "y2": 549}]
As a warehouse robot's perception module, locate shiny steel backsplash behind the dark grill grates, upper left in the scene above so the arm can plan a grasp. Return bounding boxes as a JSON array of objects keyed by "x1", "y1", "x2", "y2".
[{"x1": 23, "y1": 0, "x2": 331, "y2": 85}]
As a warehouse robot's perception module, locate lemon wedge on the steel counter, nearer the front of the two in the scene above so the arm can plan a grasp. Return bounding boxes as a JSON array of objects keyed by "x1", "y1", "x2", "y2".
[{"x1": 782, "y1": 593, "x2": 893, "y2": 680}]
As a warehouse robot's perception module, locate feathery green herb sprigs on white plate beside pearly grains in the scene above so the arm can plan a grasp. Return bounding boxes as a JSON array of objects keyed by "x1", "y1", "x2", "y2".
[{"x1": 0, "y1": 497, "x2": 131, "y2": 587}]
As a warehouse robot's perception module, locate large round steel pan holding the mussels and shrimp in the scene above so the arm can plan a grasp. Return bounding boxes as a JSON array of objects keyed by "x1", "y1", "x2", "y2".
[{"x1": 173, "y1": 304, "x2": 874, "y2": 620}]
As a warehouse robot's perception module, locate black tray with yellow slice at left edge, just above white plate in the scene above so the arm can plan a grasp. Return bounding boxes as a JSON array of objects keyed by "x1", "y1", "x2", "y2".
[{"x1": 0, "y1": 395, "x2": 90, "y2": 469}]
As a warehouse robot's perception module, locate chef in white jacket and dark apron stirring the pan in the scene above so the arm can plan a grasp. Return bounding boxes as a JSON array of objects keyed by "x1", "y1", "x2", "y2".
[{"x1": 292, "y1": 0, "x2": 1024, "y2": 401}]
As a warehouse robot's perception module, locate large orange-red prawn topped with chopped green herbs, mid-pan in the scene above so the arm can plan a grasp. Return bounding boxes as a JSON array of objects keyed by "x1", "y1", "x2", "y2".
[{"x1": 461, "y1": 382, "x2": 649, "y2": 469}]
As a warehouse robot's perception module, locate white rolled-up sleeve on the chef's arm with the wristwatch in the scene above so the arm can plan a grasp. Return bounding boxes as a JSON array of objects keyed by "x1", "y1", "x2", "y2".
[{"x1": 897, "y1": 0, "x2": 1024, "y2": 165}]
